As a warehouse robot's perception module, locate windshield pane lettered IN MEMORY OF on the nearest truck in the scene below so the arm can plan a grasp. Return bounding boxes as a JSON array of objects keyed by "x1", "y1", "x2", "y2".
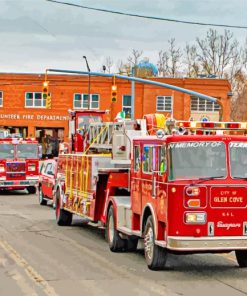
[{"x1": 169, "y1": 141, "x2": 227, "y2": 180}]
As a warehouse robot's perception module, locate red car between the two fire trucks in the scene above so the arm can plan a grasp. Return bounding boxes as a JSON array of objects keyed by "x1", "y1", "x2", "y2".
[{"x1": 39, "y1": 158, "x2": 57, "y2": 207}]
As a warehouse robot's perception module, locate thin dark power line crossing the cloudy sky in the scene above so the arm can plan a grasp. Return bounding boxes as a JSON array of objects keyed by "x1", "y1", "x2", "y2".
[{"x1": 46, "y1": 0, "x2": 247, "y2": 29}]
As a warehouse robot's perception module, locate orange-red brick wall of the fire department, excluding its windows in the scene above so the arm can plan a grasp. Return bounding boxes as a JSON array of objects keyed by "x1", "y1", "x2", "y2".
[{"x1": 0, "y1": 73, "x2": 230, "y2": 137}]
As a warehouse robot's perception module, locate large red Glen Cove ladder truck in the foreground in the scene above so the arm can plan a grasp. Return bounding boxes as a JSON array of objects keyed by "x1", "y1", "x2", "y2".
[{"x1": 55, "y1": 111, "x2": 247, "y2": 270}]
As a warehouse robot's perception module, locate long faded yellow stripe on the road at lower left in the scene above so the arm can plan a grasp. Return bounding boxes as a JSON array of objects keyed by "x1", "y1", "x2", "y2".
[{"x1": 0, "y1": 240, "x2": 58, "y2": 296}]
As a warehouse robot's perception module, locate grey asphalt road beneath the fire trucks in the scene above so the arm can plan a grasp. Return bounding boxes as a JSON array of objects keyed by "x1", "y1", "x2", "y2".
[{"x1": 0, "y1": 191, "x2": 247, "y2": 296}]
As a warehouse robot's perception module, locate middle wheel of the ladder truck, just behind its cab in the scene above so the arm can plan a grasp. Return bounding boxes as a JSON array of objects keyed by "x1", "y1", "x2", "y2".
[{"x1": 106, "y1": 206, "x2": 125, "y2": 252}]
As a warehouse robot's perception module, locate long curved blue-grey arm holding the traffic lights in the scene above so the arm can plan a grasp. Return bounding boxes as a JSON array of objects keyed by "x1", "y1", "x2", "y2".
[{"x1": 46, "y1": 69, "x2": 223, "y2": 121}]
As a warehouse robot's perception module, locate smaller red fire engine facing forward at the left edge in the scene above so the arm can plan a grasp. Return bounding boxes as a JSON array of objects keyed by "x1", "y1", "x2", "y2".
[{"x1": 0, "y1": 130, "x2": 41, "y2": 194}]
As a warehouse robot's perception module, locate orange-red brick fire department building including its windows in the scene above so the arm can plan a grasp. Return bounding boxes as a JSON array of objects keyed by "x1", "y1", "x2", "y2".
[{"x1": 0, "y1": 73, "x2": 231, "y2": 154}]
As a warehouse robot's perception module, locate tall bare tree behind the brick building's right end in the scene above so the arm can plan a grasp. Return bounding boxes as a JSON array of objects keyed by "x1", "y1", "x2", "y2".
[{"x1": 182, "y1": 29, "x2": 247, "y2": 120}]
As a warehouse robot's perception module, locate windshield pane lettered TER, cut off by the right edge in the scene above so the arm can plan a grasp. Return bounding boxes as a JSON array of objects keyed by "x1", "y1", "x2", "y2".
[{"x1": 229, "y1": 142, "x2": 247, "y2": 179}]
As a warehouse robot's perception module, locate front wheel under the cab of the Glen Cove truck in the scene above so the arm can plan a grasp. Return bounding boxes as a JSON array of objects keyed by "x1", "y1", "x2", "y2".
[{"x1": 144, "y1": 216, "x2": 167, "y2": 270}]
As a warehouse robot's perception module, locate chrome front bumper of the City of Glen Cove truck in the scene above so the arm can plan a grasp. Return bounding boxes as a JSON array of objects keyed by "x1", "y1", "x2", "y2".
[{"x1": 166, "y1": 236, "x2": 247, "y2": 251}]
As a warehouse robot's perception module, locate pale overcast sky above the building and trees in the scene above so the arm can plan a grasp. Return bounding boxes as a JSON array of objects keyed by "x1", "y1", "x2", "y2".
[{"x1": 0, "y1": 0, "x2": 247, "y2": 72}]
